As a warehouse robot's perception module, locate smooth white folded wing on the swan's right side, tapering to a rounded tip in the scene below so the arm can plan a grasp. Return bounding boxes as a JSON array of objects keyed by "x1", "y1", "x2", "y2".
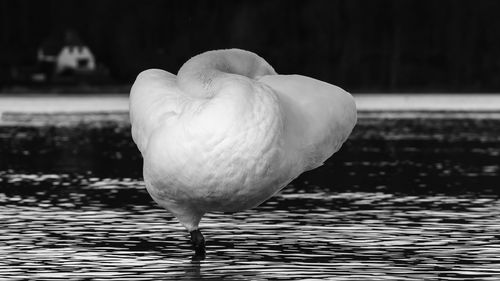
[{"x1": 259, "y1": 75, "x2": 357, "y2": 171}]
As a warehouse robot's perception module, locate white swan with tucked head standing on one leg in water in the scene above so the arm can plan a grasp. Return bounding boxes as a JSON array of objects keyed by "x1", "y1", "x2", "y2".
[{"x1": 130, "y1": 49, "x2": 357, "y2": 254}]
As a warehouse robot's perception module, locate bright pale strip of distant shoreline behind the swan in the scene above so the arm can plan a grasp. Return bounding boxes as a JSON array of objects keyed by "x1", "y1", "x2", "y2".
[{"x1": 0, "y1": 92, "x2": 500, "y2": 111}]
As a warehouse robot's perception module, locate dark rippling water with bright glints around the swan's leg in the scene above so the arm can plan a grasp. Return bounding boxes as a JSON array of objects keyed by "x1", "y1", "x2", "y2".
[{"x1": 0, "y1": 115, "x2": 500, "y2": 280}]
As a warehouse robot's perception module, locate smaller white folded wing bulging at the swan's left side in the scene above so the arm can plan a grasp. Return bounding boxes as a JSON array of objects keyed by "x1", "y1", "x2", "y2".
[{"x1": 129, "y1": 69, "x2": 185, "y2": 154}]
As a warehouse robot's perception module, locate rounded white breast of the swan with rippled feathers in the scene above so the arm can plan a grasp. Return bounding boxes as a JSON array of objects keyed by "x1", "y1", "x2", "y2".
[{"x1": 144, "y1": 77, "x2": 294, "y2": 211}]
